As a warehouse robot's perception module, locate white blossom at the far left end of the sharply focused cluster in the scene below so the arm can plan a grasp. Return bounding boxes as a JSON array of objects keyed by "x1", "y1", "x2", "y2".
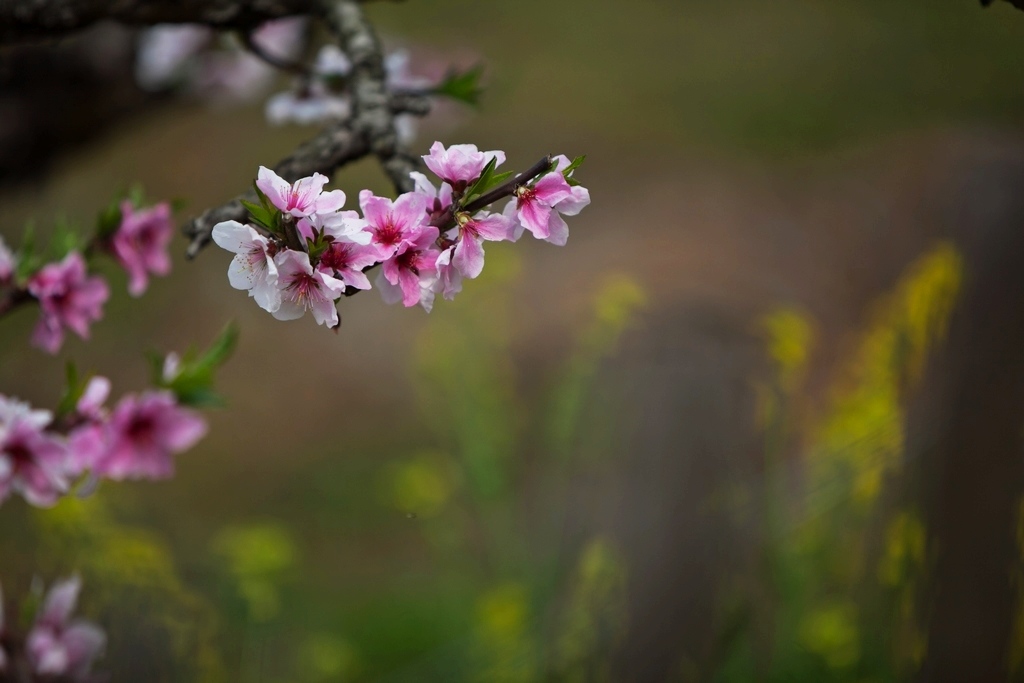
[{"x1": 212, "y1": 220, "x2": 281, "y2": 313}]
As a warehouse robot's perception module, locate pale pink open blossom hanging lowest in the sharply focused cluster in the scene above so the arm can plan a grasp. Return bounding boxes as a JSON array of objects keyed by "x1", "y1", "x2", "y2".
[{"x1": 273, "y1": 250, "x2": 345, "y2": 328}]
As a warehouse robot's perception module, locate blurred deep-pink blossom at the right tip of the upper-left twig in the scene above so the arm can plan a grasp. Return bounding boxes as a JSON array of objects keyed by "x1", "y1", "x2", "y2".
[{"x1": 111, "y1": 201, "x2": 174, "y2": 297}]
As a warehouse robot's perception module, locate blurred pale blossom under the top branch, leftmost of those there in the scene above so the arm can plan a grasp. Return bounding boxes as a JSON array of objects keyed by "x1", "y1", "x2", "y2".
[{"x1": 135, "y1": 24, "x2": 213, "y2": 90}]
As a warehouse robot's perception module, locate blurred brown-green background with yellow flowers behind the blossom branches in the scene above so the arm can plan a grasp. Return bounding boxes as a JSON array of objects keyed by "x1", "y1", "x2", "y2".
[{"x1": 0, "y1": 0, "x2": 1024, "y2": 683}]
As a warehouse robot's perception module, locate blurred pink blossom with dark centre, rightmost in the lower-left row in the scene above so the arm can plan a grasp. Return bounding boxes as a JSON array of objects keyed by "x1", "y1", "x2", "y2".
[{"x1": 93, "y1": 391, "x2": 206, "y2": 480}]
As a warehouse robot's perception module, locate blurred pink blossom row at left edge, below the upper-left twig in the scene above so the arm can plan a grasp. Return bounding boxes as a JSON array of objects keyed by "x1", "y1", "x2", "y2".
[{"x1": 0, "y1": 377, "x2": 206, "y2": 507}]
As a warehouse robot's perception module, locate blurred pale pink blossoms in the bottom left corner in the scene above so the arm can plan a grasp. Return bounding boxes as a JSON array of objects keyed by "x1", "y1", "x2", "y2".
[{"x1": 0, "y1": 577, "x2": 106, "y2": 683}]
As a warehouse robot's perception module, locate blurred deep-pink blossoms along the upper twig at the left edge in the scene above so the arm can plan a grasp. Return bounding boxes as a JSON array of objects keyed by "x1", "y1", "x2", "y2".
[{"x1": 0, "y1": 200, "x2": 174, "y2": 353}]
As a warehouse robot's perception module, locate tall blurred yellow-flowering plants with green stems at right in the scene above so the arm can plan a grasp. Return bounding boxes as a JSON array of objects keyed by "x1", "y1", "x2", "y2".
[{"x1": 716, "y1": 243, "x2": 964, "y2": 682}]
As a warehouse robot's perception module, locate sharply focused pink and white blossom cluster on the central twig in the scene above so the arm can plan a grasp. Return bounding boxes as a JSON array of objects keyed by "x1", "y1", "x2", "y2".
[{"x1": 213, "y1": 142, "x2": 590, "y2": 327}]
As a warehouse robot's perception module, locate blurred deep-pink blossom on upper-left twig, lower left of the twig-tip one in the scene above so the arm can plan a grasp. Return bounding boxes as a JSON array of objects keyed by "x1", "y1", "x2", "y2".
[{"x1": 29, "y1": 252, "x2": 110, "y2": 353}]
